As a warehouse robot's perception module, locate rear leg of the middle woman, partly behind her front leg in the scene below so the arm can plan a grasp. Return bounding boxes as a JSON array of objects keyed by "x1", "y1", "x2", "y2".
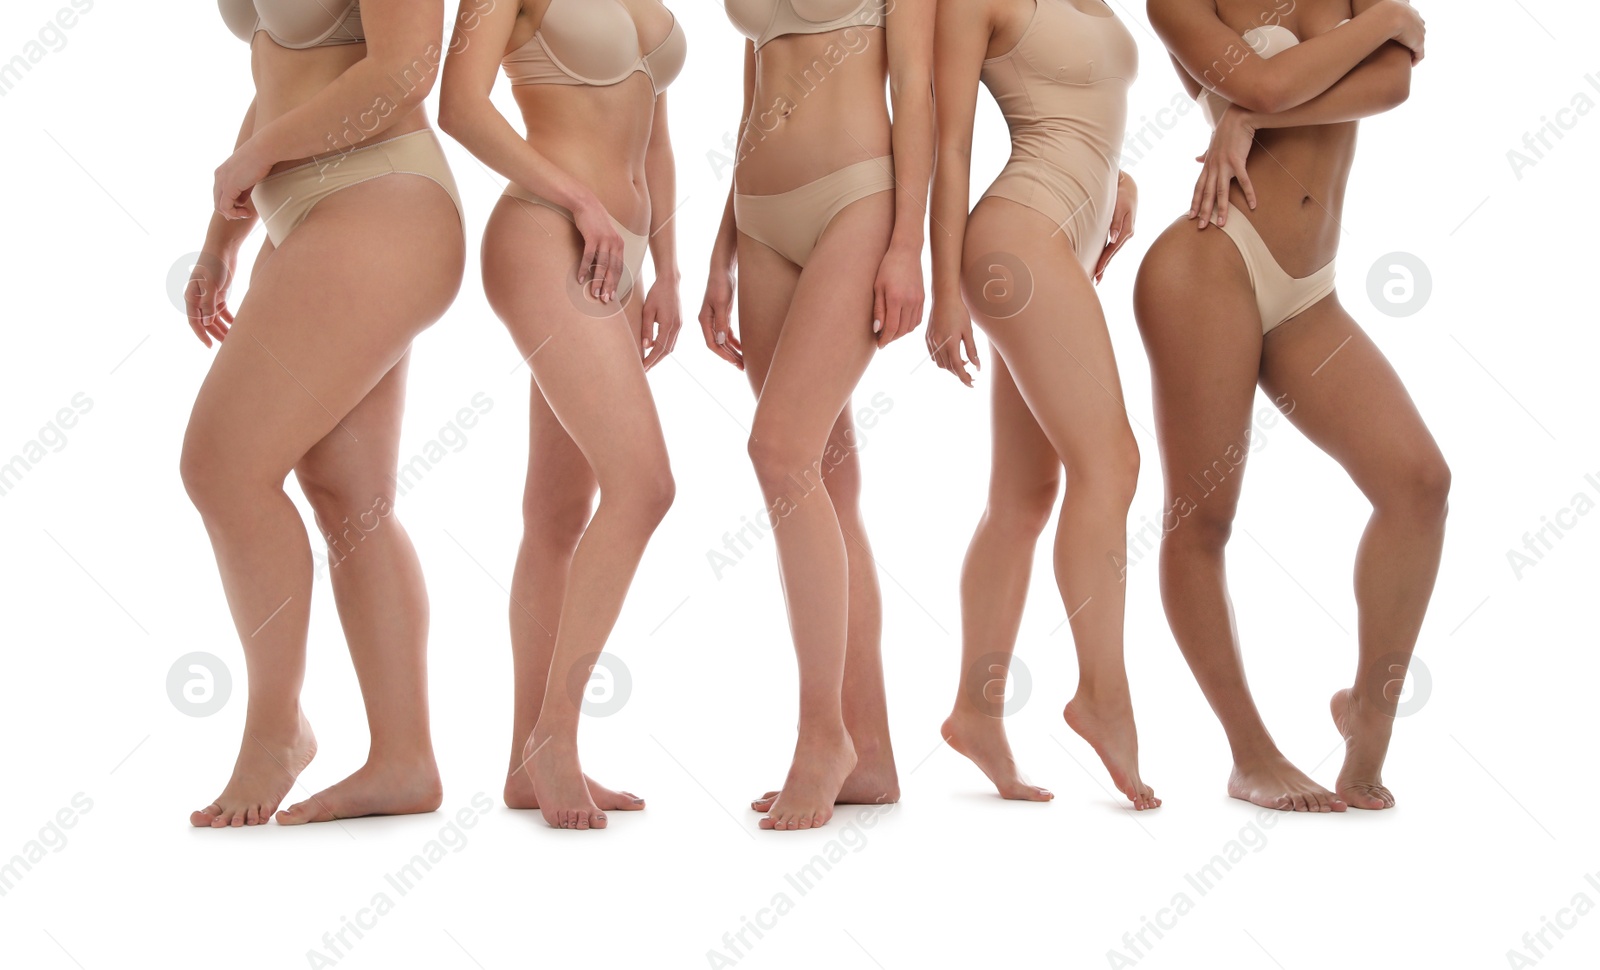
[{"x1": 739, "y1": 234, "x2": 899, "y2": 813}]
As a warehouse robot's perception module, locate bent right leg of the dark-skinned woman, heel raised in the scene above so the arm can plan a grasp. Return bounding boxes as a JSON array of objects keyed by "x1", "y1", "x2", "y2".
[{"x1": 1261, "y1": 298, "x2": 1450, "y2": 808}]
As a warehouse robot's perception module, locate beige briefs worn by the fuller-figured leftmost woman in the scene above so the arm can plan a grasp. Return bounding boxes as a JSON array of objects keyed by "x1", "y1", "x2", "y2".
[{"x1": 250, "y1": 128, "x2": 466, "y2": 247}]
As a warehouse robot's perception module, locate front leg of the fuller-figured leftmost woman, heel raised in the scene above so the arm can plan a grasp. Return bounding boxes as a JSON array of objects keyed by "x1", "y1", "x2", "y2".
[{"x1": 181, "y1": 174, "x2": 466, "y2": 828}]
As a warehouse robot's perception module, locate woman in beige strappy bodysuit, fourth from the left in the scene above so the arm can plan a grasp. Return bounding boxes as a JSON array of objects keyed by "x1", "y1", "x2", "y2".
[{"x1": 928, "y1": 0, "x2": 1162, "y2": 810}]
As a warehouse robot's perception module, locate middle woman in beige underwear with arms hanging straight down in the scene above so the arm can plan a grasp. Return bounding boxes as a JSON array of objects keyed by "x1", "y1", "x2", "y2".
[{"x1": 699, "y1": 0, "x2": 933, "y2": 829}]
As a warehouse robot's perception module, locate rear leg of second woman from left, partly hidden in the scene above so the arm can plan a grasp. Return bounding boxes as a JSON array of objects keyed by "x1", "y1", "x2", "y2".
[{"x1": 504, "y1": 384, "x2": 645, "y2": 812}]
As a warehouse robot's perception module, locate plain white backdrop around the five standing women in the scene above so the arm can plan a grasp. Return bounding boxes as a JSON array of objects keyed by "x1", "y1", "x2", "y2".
[{"x1": 0, "y1": 0, "x2": 1600, "y2": 970}]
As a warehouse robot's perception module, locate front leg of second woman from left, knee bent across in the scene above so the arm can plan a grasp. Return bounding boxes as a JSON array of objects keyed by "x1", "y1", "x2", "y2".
[{"x1": 483, "y1": 198, "x2": 674, "y2": 829}]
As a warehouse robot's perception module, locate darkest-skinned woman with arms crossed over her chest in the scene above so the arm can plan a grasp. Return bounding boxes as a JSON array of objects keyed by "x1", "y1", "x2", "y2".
[{"x1": 1134, "y1": 0, "x2": 1450, "y2": 812}]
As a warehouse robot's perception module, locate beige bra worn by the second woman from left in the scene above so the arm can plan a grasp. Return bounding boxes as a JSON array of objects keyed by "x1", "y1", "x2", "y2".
[{"x1": 501, "y1": 0, "x2": 688, "y2": 94}]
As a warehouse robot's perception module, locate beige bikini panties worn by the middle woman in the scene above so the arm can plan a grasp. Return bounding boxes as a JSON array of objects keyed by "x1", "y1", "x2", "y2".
[{"x1": 733, "y1": 155, "x2": 894, "y2": 266}]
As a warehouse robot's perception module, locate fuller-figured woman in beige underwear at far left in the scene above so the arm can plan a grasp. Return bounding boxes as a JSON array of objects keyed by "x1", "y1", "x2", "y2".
[{"x1": 181, "y1": 0, "x2": 466, "y2": 828}]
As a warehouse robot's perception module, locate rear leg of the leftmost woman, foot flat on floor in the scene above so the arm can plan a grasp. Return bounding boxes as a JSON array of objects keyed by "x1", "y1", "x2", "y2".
[{"x1": 277, "y1": 352, "x2": 443, "y2": 824}]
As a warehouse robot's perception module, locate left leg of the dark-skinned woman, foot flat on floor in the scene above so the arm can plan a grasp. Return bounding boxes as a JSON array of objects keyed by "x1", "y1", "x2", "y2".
[{"x1": 1134, "y1": 219, "x2": 1344, "y2": 812}]
